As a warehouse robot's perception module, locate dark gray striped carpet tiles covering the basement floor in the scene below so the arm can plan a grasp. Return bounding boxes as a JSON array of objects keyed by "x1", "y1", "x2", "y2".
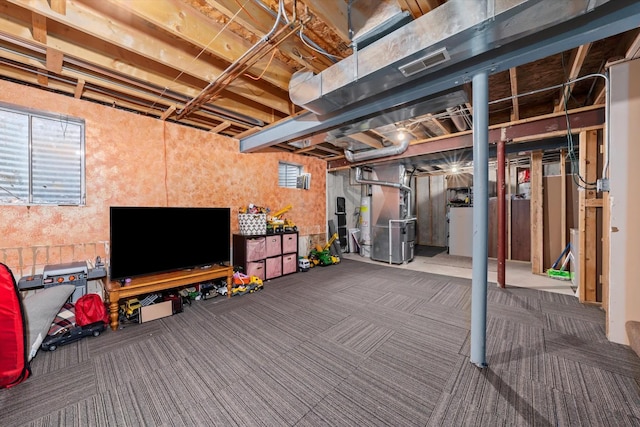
[{"x1": 0, "y1": 260, "x2": 640, "y2": 427}]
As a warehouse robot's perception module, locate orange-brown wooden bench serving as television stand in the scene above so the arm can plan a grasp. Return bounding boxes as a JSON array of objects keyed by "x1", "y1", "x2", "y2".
[{"x1": 106, "y1": 266, "x2": 233, "y2": 331}]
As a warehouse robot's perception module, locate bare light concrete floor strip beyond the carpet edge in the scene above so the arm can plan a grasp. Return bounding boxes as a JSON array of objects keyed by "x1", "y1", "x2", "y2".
[{"x1": 342, "y1": 249, "x2": 576, "y2": 295}]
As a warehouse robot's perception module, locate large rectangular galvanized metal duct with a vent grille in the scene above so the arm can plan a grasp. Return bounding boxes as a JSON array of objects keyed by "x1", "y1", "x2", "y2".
[{"x1": 289, "y1": 0, "x2": 611, "y2": 116}]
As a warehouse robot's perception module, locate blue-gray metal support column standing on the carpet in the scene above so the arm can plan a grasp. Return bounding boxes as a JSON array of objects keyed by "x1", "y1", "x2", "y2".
[{"x1": 471, "y1": 71, "x2": 489, "y2": 368}]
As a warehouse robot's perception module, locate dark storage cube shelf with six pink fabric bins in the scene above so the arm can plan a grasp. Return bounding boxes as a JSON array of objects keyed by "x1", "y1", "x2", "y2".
[{"x1": 233, "y1": 232, "x2": 298, "y2": 280}]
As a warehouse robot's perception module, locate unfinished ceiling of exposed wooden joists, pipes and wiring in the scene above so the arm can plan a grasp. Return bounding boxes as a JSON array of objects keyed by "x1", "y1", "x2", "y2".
[{"x1": 0, "y1": 0, "x2": 640, "y2": 171}]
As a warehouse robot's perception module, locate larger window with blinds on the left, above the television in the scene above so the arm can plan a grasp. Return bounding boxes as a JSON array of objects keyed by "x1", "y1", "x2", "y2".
[{"x1": 0, "y1": 104, "x2": 85, "y2": 206}]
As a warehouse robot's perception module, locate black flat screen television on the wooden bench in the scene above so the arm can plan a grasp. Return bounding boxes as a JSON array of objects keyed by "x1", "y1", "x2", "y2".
[{"x1": 109, "y1": 206, "x2": 231, "y2": 280}]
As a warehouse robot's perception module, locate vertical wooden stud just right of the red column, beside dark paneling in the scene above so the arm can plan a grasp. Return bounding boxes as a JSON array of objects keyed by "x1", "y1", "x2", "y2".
[{"x1": 531, "y1": 150, "x2": 544, "y2": 274}]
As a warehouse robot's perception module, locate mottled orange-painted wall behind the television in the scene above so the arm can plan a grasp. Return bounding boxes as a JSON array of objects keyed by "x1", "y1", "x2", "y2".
[{"x1": 0, "y1": 81, "x2": 326, "y2": 276}]
